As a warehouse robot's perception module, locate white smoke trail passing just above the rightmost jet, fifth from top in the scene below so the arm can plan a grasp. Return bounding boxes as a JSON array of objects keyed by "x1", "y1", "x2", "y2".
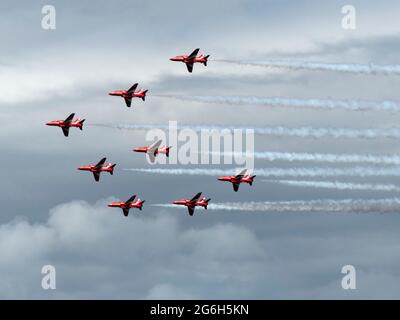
[{"x1": 124, "y1": 167, "x2": 400, "y2": 178}]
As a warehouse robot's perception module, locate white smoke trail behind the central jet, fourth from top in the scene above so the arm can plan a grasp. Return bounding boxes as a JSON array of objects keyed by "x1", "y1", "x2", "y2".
[{"x1": 208, "y1": 152, "x2": 400, "y2": 165}]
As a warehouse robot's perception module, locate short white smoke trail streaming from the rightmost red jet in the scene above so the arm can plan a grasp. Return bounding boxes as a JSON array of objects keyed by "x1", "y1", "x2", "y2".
[{"x1": 270, "y1": 180, "x2": 400, "y2": 192}]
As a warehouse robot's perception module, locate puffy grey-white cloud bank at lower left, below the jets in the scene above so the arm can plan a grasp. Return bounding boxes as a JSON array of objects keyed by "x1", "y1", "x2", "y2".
[{"x1": 0, "y1": 199, "x2": 264, "y2": 298}]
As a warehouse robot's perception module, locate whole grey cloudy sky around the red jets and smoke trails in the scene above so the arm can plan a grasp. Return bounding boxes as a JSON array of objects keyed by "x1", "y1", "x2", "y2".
[{"x1": 0, "y1": 0, "x2": 400, "y2": 299}]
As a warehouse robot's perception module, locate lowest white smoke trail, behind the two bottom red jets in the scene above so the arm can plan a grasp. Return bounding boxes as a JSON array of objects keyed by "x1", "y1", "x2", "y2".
[{"x1": 152, "y1": 198, "x2": 400, "y2": 213}]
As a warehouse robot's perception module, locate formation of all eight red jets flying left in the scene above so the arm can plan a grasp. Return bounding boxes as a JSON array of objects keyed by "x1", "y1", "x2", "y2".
[{"x1": 46, "y1": 48, "x2": 256, "y2": 217}]
